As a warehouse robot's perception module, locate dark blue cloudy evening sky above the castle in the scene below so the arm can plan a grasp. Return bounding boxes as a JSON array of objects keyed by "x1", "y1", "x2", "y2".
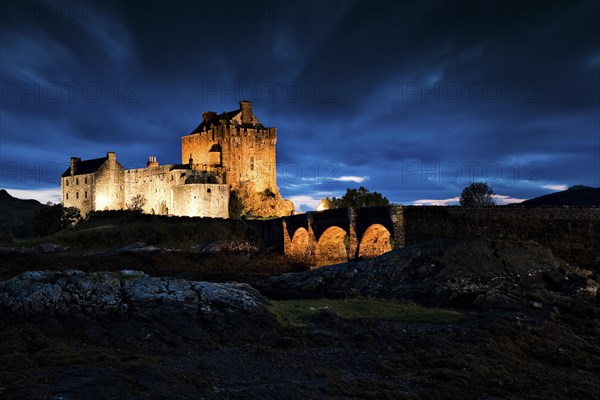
[{"x1": 0, "y1": 0, "x2": 600, "y2": 210}]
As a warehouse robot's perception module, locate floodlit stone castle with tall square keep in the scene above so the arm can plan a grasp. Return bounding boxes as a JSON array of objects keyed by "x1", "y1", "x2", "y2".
[{"x1": 61, "y1": 101, "x2": 293, "y2": 218}]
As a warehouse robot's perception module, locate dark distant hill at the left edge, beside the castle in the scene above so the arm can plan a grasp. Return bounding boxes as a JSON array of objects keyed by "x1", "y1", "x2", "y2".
[{"x1": 0, "y1": 189, "x2": 44, "y2": 237}]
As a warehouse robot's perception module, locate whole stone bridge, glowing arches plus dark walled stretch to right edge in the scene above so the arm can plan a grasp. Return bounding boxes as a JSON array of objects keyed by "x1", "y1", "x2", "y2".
[{"x1": 248, "y1": 206, "x2": 600, "y2": 273}]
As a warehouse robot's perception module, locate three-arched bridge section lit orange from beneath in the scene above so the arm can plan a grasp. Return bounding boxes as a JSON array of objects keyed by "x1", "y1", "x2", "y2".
[{"x1": 248, "y1": 206, "x2": 405, "y2": 267}]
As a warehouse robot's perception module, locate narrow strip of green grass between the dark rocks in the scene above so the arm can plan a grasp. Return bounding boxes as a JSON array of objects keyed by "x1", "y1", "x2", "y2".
[{"x1": 269, "y1": 298, "x2": 464, "y2": 326}]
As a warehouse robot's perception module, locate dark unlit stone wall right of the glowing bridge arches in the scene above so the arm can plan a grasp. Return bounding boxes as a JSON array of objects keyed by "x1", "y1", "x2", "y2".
[{"x1": 403, "y1": 206, "x2": 600, "y2": 270}]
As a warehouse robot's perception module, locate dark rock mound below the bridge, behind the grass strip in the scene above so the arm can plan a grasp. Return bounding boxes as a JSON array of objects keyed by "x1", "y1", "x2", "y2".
[{"x1": 260, "y1": 240, "x2": 599, "y2": 309}]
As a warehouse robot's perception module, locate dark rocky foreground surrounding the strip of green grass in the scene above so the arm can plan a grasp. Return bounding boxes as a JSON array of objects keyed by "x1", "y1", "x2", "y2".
[{"x1": 0, "y1": 240, "x2": 600, "y2": 399}]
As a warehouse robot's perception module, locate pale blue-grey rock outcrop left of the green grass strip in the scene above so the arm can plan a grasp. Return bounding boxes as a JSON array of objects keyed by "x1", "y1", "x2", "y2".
[{"x1": 0, "y1": 270, "x2": 275, "y2": 343}]
